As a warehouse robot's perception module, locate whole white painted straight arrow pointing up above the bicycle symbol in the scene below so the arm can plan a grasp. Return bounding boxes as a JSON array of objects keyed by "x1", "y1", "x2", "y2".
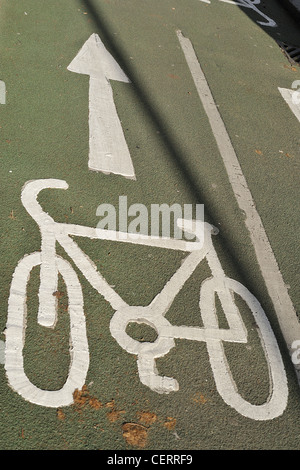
[{"x1": 67, "y1": 34, "x2": 135, "y2": 179}]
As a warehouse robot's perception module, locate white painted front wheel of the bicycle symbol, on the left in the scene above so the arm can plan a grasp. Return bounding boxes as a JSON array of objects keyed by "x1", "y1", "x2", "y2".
[{"x1": 5, "y1": 252, "x2": 89, "y2": 408}]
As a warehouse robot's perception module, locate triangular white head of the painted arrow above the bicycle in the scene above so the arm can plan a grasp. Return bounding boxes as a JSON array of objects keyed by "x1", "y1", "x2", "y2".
[{"x1": 67, "y1": 33, "x2": 130, "y2": 83}]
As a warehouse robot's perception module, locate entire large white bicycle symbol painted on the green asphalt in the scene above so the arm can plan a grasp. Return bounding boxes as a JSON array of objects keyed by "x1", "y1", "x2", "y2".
[{"x1": 5, "y1": 179, "x2": 288, "y2": 420}]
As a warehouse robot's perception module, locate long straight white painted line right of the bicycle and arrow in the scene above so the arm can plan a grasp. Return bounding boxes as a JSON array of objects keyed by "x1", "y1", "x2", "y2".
[{"x1": 177, "y1": 31, "x2": 300, "y2": 380}]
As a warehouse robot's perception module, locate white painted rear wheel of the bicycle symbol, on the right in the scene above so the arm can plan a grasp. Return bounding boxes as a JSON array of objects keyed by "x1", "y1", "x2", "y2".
[{"x1": 200, "y1": 278, "x2": 288, "y2": 420}]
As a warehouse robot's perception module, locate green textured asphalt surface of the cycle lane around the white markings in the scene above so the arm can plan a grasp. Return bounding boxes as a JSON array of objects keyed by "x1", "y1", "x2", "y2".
[{"x1": 0, "y1": 0, "x2": 300, "y2": 451}]
